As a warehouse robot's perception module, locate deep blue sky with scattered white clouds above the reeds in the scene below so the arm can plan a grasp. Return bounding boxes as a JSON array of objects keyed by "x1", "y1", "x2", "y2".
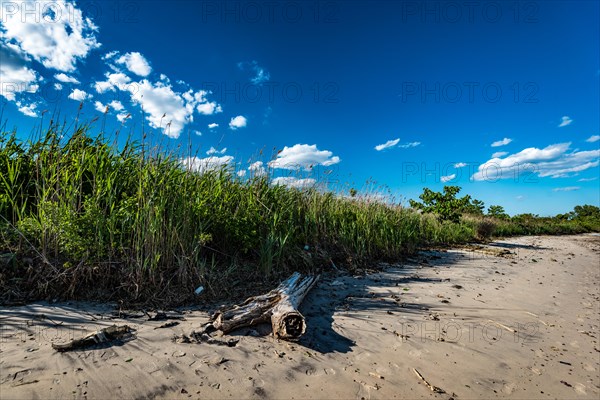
[{"x1": 0, "y1": 0, "x2": 600, "y2": 215}]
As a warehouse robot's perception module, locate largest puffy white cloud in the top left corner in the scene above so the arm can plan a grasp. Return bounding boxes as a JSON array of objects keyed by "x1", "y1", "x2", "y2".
[{"x1": 2, "y1": 0, "x2": 100, "y2": 72}]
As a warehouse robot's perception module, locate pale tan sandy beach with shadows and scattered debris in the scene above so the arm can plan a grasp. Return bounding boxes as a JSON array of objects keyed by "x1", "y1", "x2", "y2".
[{"x1": 0, "y1": 235, "x2": 600, "y2": 399}]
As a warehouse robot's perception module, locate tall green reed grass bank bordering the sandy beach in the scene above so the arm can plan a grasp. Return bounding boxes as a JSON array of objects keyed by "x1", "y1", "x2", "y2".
[{"x1": 0, "y1": 125, "x2": 598, "y2": 304}]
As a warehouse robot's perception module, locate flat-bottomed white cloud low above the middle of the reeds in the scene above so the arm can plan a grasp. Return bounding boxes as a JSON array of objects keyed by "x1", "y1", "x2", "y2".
[{"x1": 269, "y1": 144, "x2": 341, "y2": 170}]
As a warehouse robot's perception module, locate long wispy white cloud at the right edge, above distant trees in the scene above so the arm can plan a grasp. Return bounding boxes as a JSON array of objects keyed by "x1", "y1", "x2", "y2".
[{"x1": 472, "y1": 143, "x2": 600, "y2": 181}]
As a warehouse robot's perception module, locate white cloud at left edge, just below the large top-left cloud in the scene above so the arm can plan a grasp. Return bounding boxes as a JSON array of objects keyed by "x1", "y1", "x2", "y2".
[{"x1": 0, "y1": 42, "x2": 42, "y2": 101}]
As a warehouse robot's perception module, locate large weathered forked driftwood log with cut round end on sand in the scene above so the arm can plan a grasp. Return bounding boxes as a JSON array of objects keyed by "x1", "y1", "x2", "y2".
[{"x1": 212, "y1": 272, "x2": 319, "y2": 340}]
